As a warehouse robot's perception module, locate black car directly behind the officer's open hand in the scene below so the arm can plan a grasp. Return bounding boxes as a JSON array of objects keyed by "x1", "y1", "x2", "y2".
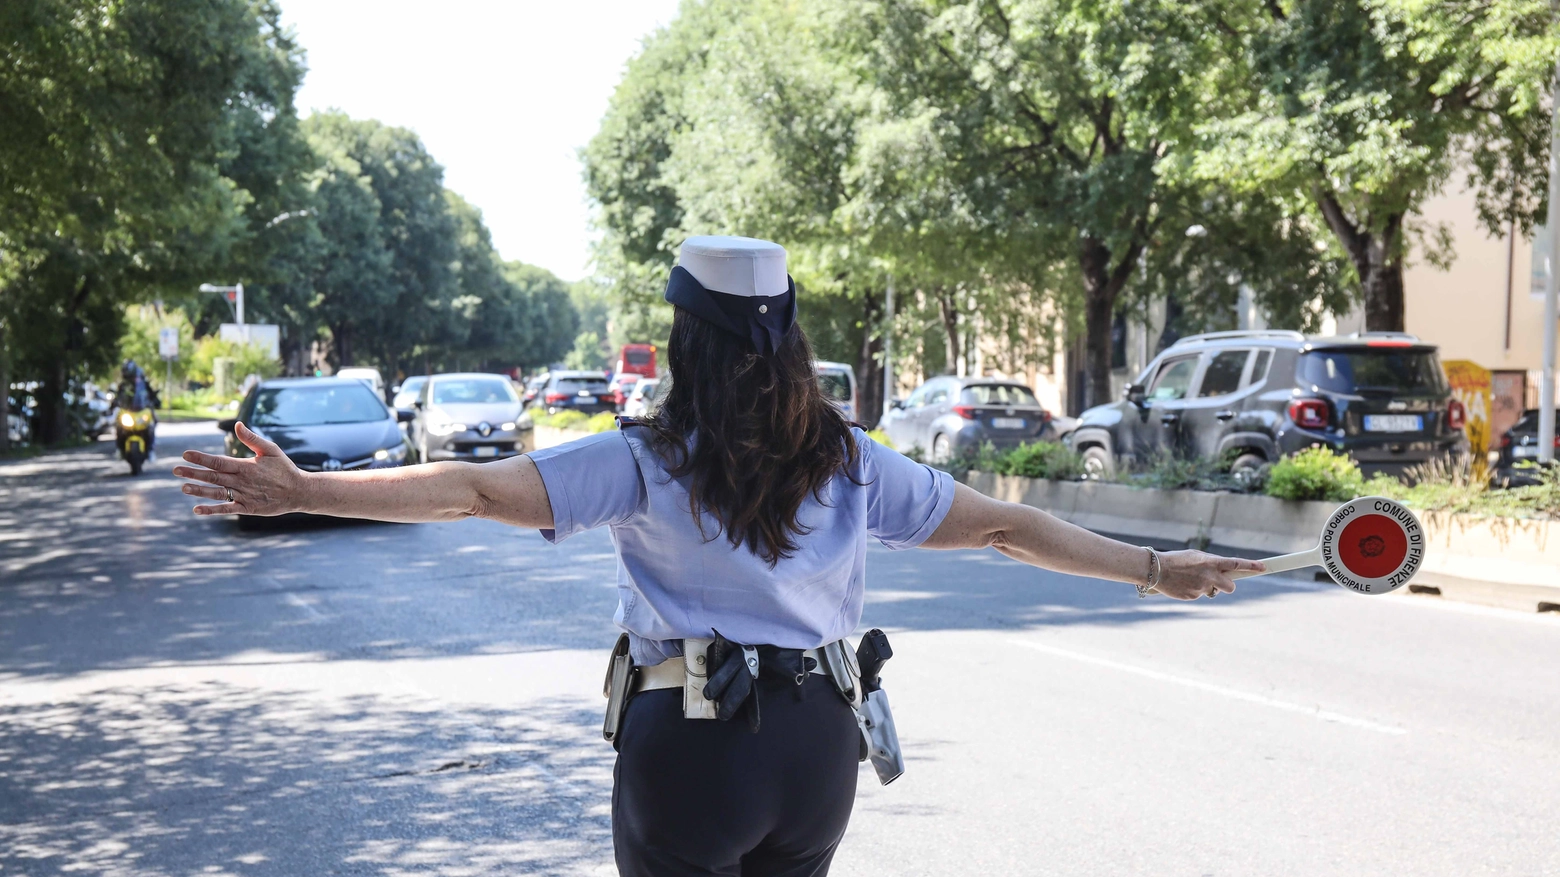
[{"x1": 217, "y1": 378, "x2": 412, "y2": 471}]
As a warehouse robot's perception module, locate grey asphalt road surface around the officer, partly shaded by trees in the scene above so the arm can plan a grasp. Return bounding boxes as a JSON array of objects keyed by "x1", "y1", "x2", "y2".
[{"x1": 0, "y1": 424, "x2": 1560, "y2": 875}]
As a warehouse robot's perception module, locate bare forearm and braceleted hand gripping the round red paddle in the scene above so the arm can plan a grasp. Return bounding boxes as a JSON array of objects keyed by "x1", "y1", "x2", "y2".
[{"x1": 920, "y1": 484, "x2": 1262, "y2": 599}]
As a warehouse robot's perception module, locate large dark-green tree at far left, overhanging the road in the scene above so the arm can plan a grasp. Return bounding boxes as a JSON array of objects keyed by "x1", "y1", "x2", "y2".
[{"x1": 0, "y1": 0, "x2": 310, "y2": 442}]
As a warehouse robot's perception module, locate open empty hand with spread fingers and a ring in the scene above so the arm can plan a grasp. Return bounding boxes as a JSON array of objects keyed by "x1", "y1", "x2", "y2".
[{"x1": 173, "y1": 423, "x2": 307, "y2": 515}]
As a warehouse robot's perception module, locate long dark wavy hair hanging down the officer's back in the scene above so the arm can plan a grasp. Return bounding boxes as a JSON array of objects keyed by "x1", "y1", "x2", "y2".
[{"x1": 644, "y1": 307, "x2": 860, "y2": 566}]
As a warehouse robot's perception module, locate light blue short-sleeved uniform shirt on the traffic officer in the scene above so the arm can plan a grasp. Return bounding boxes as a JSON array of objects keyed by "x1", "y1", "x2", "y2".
[{"x1": 530, "y1": 426, "x2": 953, "y2": 665}]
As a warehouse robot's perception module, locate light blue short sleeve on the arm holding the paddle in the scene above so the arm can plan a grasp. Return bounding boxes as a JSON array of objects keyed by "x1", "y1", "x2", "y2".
[{"x1": 855, "y1": 429, "x2": 953, "y2": 551}]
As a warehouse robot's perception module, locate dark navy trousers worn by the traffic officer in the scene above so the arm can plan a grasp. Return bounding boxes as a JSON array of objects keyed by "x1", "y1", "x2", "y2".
[{"x1": 612, "y1": 674, "x2": 861, "y2": 877}]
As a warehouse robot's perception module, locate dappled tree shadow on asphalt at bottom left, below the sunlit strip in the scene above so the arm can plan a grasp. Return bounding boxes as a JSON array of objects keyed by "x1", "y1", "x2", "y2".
[{"x1": 0, "y1": 683, "x2": 613, "y2": 877}]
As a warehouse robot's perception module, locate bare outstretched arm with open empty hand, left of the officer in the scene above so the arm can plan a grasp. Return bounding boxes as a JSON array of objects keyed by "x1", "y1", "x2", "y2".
[{"x1": 173, "y1": 423, "x2": 552, "y2": 527}]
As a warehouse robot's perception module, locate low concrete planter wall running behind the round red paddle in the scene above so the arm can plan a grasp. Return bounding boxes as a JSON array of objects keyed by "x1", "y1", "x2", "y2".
[{"x1": 966, "y1": 471, "x2": 1560, "y2": 612}]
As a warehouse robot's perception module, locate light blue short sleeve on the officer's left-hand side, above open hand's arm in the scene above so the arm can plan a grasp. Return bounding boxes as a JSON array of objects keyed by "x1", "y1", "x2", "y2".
[{"x1": 527, "y1": 429, "x2": 644, "y2": 543}]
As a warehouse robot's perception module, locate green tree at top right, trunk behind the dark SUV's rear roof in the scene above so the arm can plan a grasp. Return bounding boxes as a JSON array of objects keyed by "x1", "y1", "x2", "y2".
[{"x1": 1195, "y1": 0, "x2": 1560, "y2": 331}]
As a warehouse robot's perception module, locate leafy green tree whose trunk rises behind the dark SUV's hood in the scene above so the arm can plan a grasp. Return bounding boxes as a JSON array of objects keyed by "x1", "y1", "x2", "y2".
[{"x1": 842, "y1": 0, "x2": 1285, "y2": 404}]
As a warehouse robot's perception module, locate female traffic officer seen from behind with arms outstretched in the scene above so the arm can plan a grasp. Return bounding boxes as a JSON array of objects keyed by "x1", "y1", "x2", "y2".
[{"x1": 175, "y1": 237, "x2": 1260, "y2": 877}]
